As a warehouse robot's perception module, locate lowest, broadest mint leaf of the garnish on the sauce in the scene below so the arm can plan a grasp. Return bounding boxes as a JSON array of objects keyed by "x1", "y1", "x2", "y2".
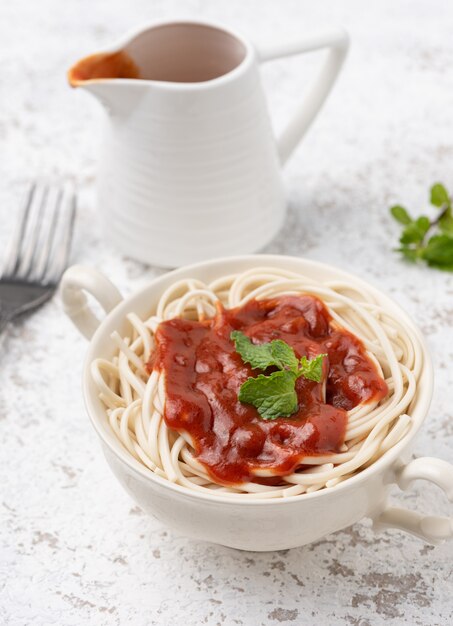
[{"x1": 239, "y1": 370, "x2": 297, "y2": 420}]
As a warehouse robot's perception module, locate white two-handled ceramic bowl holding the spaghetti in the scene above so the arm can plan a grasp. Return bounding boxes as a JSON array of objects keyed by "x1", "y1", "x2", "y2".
[{"x1": 61, "y1": 255, "x2": 453, "y2": 551}]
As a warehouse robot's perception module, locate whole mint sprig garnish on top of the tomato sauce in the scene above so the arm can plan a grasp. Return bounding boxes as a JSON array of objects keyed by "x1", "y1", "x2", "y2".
[{"x1": 230, "y1": 330, "x2": 327, "y2": 420}]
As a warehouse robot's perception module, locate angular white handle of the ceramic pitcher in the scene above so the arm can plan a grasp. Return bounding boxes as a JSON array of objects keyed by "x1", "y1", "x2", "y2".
[{"x1": 257, "y1": 28, "x2": 349, "y2": 165}]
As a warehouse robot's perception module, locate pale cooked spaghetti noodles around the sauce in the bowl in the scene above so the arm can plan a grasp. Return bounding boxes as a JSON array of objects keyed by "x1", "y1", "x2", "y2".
[{"x1": 91, "y1": 268, "x2": 422, "y2": 499}]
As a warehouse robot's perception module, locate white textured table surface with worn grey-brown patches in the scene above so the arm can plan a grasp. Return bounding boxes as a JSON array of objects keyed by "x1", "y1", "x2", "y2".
[{"x1": 0, "y1": 0, "x2": 453, "y2": 626}]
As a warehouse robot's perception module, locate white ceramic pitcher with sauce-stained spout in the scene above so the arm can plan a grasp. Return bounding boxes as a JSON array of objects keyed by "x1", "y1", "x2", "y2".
[{"x1": 69, "y1": 21, "x2": 348, "y2": 267}]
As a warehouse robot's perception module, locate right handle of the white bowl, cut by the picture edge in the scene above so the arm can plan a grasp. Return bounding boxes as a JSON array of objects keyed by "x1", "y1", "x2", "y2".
[{"x1": 374, "y1": 456, "x2": 453, "y2": 545}]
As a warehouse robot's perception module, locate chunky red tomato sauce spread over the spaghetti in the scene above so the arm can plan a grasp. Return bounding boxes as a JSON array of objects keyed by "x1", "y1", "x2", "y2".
[{"x1": 149, "y1": 295, "x2": 388, "y2": 485}]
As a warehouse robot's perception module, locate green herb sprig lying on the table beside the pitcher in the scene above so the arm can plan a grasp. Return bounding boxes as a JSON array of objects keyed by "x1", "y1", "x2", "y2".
[{"x1": 390, "y1": 183, "x2": 453, "y2": 272}]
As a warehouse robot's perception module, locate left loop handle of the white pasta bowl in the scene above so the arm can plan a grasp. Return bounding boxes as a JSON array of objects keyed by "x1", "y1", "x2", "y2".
[{"x1": 60, "y1": 265, "x2": 123, "y2": 339}]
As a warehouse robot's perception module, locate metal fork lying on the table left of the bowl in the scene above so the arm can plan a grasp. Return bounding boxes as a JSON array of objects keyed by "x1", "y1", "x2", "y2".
[{"x1": 0, "y1": 183, "x2": 76, "y2": 334}]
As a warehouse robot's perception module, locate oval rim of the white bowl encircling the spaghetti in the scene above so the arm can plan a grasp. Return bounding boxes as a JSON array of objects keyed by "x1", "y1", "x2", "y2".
[{"x1": 79, "y1": 254, "x2": 433, "y2": 506}]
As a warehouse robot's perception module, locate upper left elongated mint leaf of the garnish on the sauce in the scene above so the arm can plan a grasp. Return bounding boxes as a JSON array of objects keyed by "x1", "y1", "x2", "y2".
[{"x1": 230, "y1": 330, "x2": 298, "y2": 373}]
